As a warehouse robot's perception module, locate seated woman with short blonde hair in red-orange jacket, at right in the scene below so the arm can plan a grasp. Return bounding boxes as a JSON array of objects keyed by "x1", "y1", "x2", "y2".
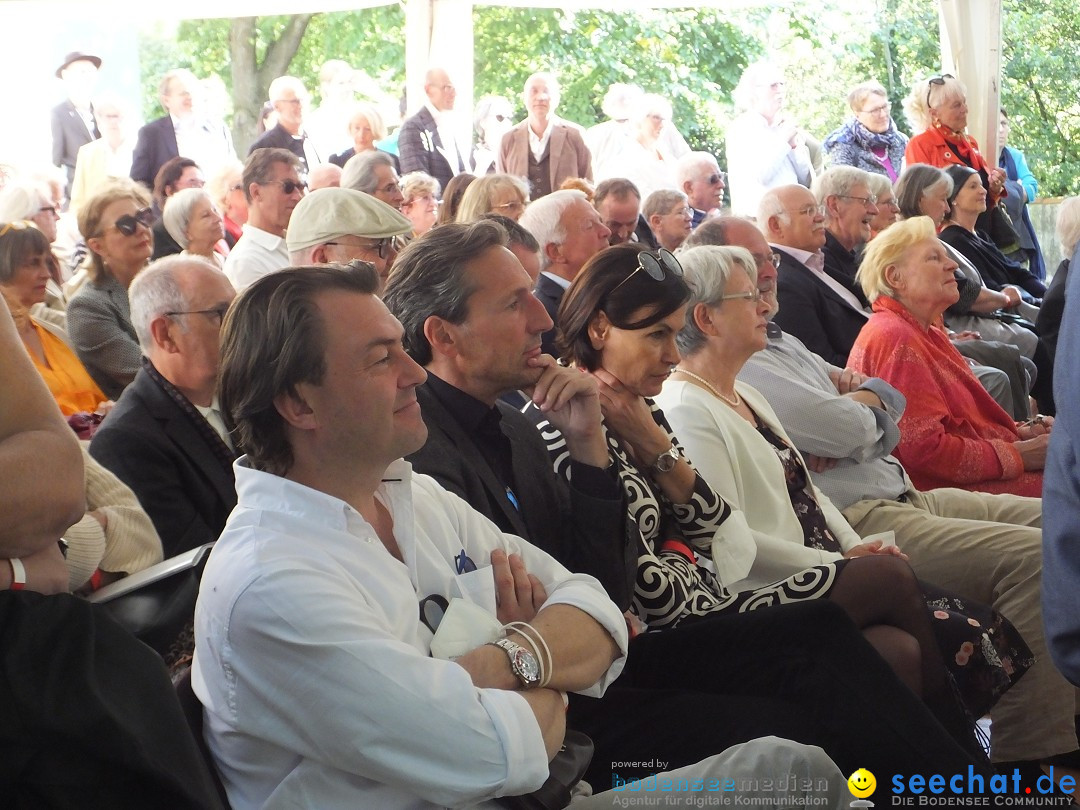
[{"x1": 848, "y1": 216, "x2": 1053, "y2": 498}]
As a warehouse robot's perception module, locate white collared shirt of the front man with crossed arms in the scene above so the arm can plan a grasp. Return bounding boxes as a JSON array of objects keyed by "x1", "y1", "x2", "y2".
[{"x1": 192, "y1": 457, "x2": 627, "y2": 810}]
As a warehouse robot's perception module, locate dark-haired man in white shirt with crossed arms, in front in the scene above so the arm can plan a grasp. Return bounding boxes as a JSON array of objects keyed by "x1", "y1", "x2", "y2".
[{"x1": 192, "y1": 266, "x2": 842, "y2": 810}]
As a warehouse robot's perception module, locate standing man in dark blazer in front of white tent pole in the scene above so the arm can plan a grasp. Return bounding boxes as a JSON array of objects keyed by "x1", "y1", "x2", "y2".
[{"x1": 397, "y1": 68, "x2": 468, "y2": 195}]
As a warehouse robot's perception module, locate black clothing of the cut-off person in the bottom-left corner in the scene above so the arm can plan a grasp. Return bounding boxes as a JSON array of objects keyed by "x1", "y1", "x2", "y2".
[{"x1": 0, "y1": 591, "x2": 221, "y2": 810}]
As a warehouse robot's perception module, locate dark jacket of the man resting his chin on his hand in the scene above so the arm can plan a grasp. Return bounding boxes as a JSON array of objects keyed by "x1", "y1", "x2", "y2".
[{"x1": 407, "y1": 383, "x2": 640, "y2": 610}]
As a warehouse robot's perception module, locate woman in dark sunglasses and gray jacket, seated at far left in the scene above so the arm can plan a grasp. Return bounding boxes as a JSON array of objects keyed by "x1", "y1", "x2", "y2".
[{"x1": 67, "y1": 180, "x2": 153, "y2": 400}]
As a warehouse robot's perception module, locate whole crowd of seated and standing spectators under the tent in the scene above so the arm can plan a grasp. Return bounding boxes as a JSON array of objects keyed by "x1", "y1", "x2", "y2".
[{"x1": 6, "y1": 49, "x2": 1080, "y2": 808}]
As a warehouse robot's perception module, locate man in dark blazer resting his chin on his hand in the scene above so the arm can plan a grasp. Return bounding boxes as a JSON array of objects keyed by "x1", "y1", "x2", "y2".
[{"x1": 384, "y1": 221, "x2": 637, "y2": 609}]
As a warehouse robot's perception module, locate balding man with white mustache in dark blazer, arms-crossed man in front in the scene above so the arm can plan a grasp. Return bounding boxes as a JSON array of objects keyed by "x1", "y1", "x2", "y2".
[{"x1": 758, "y1": 185, "x2": 869, "y2": 368}]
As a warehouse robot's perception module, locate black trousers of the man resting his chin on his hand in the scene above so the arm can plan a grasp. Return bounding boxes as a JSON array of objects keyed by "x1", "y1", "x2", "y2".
[{"x1": 567, "y1": 599, "x2": 993, "y2": 791}]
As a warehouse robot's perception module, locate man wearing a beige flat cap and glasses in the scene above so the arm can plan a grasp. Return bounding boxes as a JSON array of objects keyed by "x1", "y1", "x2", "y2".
[{"x1": 285, "y1": 188, "x2": 413, "y2": 292}]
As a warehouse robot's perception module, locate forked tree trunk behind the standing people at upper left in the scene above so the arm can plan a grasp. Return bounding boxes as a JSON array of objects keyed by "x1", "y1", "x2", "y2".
[{"x1": 229, "y1": 14, "x2": 313, "y2": 158}]
